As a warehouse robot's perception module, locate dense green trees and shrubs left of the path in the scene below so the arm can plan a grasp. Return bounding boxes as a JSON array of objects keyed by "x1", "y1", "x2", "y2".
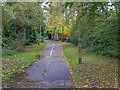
[{"x1": 2, "y1": 2, "x2": 44, "y2": 55}]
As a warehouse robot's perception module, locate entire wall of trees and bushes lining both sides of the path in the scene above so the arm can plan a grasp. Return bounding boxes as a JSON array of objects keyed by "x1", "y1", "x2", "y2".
[{"x1": 2, "y1": 2, "x2": 120, "y2": 57}]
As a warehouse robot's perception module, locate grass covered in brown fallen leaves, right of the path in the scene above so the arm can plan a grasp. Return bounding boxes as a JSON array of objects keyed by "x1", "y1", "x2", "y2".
[{"x1": 62, "y1": 43, "x2": 118, "y2": 88}]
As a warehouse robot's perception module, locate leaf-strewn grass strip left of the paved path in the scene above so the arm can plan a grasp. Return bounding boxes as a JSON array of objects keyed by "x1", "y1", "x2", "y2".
[{"x1": 2, "y1": 43, "x2": 46, "y2": 80}]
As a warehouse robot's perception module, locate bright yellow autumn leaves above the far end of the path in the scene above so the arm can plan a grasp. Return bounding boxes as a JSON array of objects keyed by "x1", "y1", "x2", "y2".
[{"x1": 46, "y1": 11, "x2": 72, "y2": 36}]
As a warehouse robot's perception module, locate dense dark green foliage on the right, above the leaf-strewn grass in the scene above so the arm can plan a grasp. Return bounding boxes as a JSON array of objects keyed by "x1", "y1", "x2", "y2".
[{"x1": 65, "y1": 3, "x2": 119, "y2": 58}]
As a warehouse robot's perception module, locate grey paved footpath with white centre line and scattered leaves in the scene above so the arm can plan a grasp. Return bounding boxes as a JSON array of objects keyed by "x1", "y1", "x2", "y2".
[{"x1": 8, "y1": 40, "x2": 74, "y2": 88}]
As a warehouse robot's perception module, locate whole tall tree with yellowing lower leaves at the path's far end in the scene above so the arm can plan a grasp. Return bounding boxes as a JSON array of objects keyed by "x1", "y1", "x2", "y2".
[{"x1": 46, "y1": 3, "x2": 72, "y2": 41}]
